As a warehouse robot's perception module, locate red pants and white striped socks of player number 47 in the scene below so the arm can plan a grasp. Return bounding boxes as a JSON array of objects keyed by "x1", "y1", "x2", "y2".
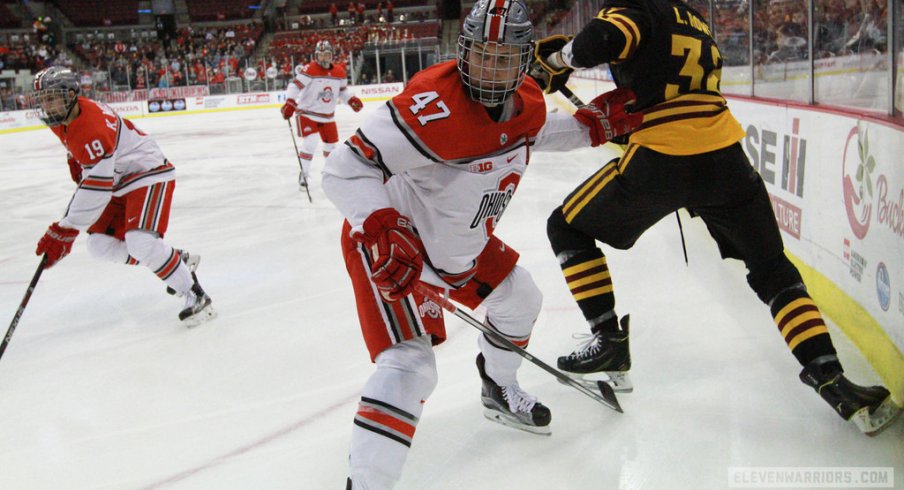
[{"x1": 342, "y1": 228, "x2": 542, "y2": 489}]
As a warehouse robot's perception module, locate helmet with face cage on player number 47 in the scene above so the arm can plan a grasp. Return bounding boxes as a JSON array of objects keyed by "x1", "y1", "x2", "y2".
[{"x1": 458, "y1": 0, "x2": 533, "y2": 106}]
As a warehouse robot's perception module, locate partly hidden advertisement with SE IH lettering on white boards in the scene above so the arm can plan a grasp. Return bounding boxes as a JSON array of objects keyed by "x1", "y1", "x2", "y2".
[{"x1": 745, "y1": 118, "x2": 807, "y2": 239}]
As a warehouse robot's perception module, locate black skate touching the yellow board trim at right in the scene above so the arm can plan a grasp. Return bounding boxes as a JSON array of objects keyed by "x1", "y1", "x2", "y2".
[{"x1": 800, "y1": 355, "x2": 901, "y2": 436}]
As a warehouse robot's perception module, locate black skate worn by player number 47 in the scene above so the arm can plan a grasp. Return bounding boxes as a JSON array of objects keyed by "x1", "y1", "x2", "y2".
[{"x1": 477, "y1": 354, "x2": 552, "y2": 435}]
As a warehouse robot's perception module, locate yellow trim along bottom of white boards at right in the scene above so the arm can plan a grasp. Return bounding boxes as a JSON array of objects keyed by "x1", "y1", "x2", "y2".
[{"x1": 786, "y1": 251, "x2": 904, "y2": 406}]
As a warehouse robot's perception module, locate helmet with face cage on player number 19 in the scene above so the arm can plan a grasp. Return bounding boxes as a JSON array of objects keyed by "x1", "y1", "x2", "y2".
[{"x1": 29, "y1": 67, "x2": 81, "y2": 126}]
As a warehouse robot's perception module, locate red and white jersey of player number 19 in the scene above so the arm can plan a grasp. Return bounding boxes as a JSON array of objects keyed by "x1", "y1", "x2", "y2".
[{"x1": 50, "y1": 97, "x2": 176, "y2": 231}]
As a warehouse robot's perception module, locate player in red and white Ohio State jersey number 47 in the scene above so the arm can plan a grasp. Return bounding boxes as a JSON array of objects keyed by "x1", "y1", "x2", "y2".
[{"x1": 323, "y1": 0, "x2": 642, "y2": 490}]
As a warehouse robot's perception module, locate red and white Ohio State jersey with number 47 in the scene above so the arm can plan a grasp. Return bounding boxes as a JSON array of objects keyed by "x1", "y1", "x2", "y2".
[{"x1": 323, "y1": 61, "x2": 590, "y2": 280}]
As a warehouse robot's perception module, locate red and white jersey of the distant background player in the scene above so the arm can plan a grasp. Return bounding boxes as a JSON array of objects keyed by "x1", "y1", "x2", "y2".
[{"x1": 286, "y1": 63, "x2": 353, "y2": 122}]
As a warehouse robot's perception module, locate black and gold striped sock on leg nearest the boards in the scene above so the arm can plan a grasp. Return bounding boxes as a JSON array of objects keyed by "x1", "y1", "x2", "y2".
[{"x1": 769, "y1": 284, "x2": 841, "y2": 369}]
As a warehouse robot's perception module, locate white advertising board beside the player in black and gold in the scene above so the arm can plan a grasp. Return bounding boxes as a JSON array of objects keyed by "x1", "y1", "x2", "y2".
[{"x1": 729, "y1": 98, "x2": 904, "y2": 352}]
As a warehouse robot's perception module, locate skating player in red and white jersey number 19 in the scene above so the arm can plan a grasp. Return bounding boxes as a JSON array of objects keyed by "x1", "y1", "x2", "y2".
[{"x1": 34, "y1": 67, "x2": 216, "y2": 327}]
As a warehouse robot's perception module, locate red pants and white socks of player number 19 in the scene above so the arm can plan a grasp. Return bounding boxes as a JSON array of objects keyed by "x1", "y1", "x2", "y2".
[{"x1": 88, "y1": 181, "x2": 194, "y2": 293}]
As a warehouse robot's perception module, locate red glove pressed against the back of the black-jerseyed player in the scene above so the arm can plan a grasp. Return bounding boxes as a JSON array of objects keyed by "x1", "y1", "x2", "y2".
[{"x1": 574, "y1": 88, "x2": 643, "y2": 146}]
